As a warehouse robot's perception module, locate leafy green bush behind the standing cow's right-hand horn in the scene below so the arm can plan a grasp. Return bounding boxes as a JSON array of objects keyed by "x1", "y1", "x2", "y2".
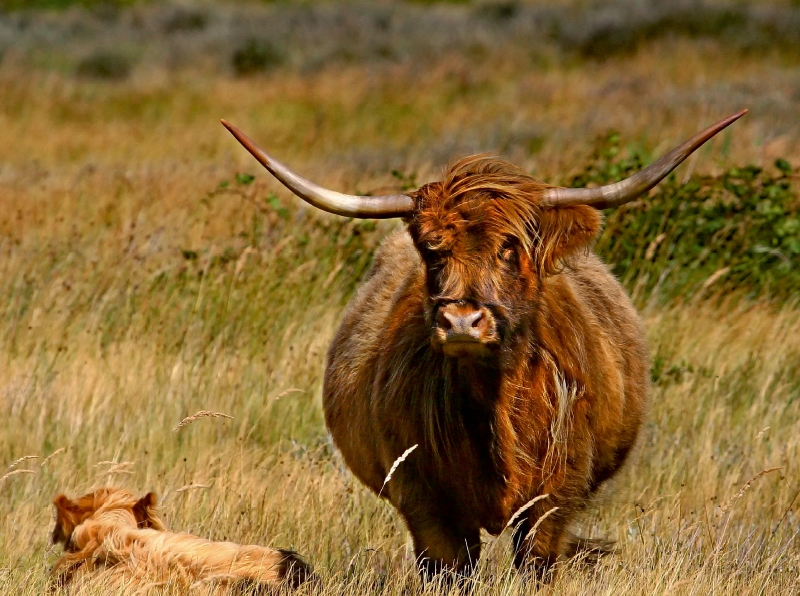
[{"x1": 571, "y1": 133, "x2": 800, "y2": 301}]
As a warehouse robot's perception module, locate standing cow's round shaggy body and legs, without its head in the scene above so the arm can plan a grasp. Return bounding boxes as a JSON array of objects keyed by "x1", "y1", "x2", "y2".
[{"x1": 324, "y1": 225, "x2": 648, "y2": 567}]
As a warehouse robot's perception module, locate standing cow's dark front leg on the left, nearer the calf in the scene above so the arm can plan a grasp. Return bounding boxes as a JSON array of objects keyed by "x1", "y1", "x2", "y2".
[{"x1": 404, "y1": 512, "x2": 481, "y2": 580}]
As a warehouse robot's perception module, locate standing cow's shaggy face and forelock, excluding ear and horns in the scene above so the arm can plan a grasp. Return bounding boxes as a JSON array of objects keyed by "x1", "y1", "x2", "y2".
[{"x1": 409, "y1": 157, "x2": 542, "y2": 353}]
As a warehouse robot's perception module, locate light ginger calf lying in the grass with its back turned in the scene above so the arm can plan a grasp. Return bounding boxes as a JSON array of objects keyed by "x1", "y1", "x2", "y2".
[{"x1": 52, "y1": 488, "x2": 311, "y2": 593}]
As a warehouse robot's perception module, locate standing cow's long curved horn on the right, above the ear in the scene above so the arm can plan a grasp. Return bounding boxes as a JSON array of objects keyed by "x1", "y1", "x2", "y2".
[{"x1": 542, "y1": 110, "x2": 747, "y2": 209}]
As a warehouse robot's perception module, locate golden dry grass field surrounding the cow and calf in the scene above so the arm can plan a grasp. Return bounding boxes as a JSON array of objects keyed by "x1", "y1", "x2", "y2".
[{"x1": 0, "y1": 3, "x2": 800, "y2": 596}]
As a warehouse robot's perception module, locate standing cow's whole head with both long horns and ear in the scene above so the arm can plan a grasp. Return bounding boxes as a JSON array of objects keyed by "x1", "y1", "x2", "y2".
[{"x1": 222, "y1": 110, "x2": 747, "y2": 358}]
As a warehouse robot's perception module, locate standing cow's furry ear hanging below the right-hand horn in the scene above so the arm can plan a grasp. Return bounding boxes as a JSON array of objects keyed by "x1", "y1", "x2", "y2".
[{"x1": 535, "y1": 205, "x2": 603, "y2": 275}]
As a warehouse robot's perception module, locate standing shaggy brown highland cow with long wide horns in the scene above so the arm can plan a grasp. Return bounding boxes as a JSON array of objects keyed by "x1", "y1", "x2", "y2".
[{"x1": 223, "y1": 112, "x2": 744, "y2": 573}]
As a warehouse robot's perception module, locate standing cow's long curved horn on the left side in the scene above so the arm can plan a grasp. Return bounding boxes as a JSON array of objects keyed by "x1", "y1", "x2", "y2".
[{"x1": 222, "y1": 120, "x2": 414, "y2": 219}]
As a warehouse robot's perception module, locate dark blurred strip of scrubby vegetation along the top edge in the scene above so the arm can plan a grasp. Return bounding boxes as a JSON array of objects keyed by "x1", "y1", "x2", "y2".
[{"x1": 0, "y1": 0, "x2": 800, "y2": 75}]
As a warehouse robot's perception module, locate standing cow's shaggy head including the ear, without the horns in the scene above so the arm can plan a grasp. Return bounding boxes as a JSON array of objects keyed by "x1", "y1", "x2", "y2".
[{"x1": 409, "y1": 158, "x2": 601, "y2": 358}]
